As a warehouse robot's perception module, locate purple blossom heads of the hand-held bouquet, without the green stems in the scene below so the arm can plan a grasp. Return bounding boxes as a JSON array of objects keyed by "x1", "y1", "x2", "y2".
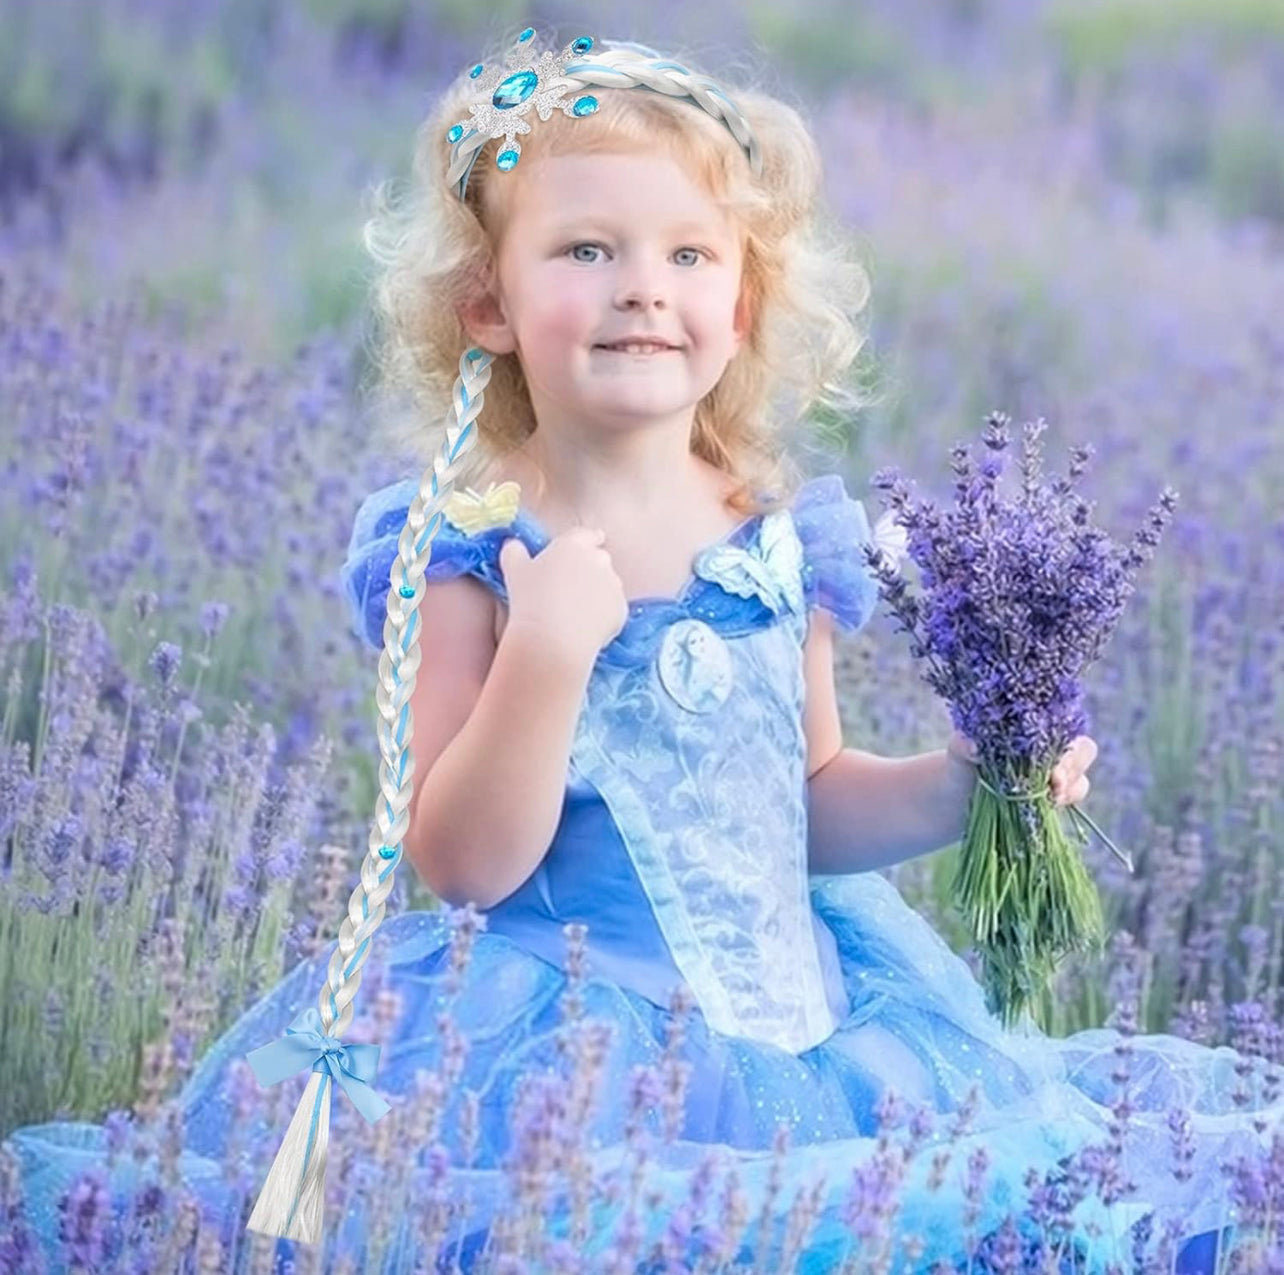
[{"x1": 865, "y1": 412, "x2": 1176, "y2": 779}]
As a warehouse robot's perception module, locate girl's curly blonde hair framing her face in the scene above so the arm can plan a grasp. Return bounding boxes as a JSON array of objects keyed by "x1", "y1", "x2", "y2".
[{"x1": 363, "y1": 41, "x2": 871, "y2": 516}]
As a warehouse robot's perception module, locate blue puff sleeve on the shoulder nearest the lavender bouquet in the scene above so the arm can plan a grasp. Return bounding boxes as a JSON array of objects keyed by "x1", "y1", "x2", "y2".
[{"x1": 791, "y1": 474, "x2": 878, "y2": 633}]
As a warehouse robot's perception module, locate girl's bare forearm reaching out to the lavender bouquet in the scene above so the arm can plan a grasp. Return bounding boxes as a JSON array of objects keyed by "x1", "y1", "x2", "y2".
[{"x1": 808, "y1": 749, "x2": 976, "y2": 876}]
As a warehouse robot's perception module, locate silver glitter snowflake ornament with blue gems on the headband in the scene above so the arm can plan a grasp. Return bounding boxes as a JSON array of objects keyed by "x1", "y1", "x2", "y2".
[{"x1": 451, "y1": 27, "x2": 598, "y2": 181}]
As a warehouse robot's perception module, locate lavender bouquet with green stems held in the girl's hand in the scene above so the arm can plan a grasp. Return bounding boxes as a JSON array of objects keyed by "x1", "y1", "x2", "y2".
[{"x1": 865, "y1": 412, "x2": 1177, "y2": 1026}]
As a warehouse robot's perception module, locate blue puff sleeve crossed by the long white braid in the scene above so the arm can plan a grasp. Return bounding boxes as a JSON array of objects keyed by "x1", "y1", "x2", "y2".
[{"x1": 339, "y1": 478, "x2": 488, "y2": 651}]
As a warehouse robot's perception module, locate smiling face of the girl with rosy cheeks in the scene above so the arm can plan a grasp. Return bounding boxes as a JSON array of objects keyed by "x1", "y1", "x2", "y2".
[{"x1": 470, "y1": 152, "x2": 747, "y2": 425}]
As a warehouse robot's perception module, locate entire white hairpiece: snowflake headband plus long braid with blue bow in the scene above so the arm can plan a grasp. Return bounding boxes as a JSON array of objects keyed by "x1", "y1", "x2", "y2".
[{"x1": 245, "y1": 27, "x2": 761, "y2": 1243}]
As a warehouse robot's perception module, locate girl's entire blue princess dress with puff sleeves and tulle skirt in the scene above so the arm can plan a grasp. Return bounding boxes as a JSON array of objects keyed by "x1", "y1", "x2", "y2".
[{"x1": 5, "y1": 475, "x2": 1284, "y2": 1272}]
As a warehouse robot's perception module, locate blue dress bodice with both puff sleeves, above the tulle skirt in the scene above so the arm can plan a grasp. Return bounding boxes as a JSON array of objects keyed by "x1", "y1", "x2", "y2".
[{"x1": 343, "y1": 475, "x2": 877, "y2": 1053}]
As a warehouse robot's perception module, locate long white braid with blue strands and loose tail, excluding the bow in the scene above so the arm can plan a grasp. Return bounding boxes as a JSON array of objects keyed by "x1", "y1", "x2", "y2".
[{"x1": 245, "y1": 348, "x2": 493, "y2": 1243}]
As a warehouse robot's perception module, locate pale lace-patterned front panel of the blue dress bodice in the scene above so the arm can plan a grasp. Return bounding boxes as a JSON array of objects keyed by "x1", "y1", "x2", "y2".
[{"x1": 571, "y1": 511, "x2": 846, "y2": 1053}]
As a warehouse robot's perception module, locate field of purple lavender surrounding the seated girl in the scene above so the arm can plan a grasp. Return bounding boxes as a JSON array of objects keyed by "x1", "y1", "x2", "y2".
[{"x1": 0, "y1": 0, "x2": 1284, "y2": 1275}]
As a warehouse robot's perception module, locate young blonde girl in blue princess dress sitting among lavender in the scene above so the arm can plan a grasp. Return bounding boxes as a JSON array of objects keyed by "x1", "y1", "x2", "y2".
[{"x1": 7, "y1": 19, "x2": 1279, "y2": 1271}]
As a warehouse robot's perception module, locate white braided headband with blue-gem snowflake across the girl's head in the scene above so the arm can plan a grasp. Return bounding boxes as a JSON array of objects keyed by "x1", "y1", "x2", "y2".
[{"x1": 446, "y1": 27, "x2": 763, "y2": 199}]
